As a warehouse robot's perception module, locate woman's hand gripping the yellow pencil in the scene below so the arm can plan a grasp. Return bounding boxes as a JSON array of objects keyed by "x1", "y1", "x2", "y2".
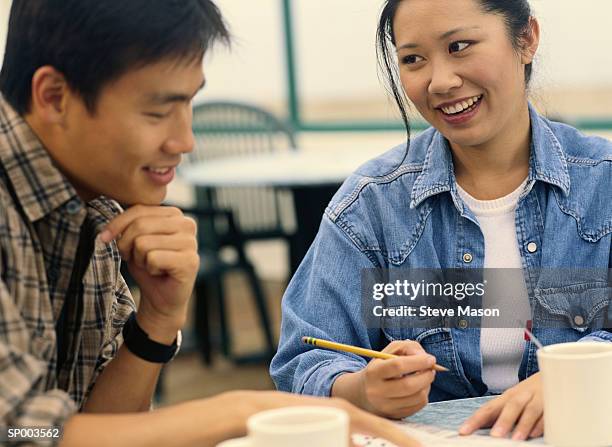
[{"x1": 332, "y1": 340, "x2": 436, "y2": 419}]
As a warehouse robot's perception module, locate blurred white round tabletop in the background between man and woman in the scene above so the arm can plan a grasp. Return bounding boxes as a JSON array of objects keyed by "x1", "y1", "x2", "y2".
[{"x1": 178, "y1": 148, "x2": 383, "y2": 187}]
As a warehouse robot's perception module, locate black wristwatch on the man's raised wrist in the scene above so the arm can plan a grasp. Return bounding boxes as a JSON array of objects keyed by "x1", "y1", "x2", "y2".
[{"x1": 122, "y1": 312, "x2": 181, "y2": 363}]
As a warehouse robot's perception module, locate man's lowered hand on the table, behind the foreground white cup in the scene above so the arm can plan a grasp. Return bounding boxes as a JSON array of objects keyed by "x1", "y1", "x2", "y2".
[{"x1": 230, "y1": 391, "x2": 420, "y2": 447}]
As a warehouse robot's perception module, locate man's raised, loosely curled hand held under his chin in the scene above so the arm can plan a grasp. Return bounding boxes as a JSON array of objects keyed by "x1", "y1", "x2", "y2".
[{"x1": 100, "y1": 205, "x2": 199, "y2": 344}]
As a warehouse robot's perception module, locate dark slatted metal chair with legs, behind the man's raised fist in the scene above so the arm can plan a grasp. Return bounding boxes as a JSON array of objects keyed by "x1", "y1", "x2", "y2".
[{"x1": 184, "y1": 102, "x2": 295, "y2": 362}]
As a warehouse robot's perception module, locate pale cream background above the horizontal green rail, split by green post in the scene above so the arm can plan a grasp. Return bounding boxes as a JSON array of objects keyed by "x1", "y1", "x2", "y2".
[{"x1": 0, "y1": 0, "x2": 612, "y2": 117}]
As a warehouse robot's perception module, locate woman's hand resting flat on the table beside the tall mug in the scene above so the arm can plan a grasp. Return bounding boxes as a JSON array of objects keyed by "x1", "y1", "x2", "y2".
[{"x1": 459, "y1": 373, "x2": 544, "y2": 440}]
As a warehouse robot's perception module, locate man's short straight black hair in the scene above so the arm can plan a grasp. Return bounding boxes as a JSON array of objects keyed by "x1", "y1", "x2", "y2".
[{"x1": 0, "y1": 0, "x2": 229, "y2": 115}]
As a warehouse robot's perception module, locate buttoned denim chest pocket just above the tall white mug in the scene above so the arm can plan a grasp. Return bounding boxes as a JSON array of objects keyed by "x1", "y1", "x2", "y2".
[{"x1": 533, "y1": 282, "x2": 612, "y2": 336}]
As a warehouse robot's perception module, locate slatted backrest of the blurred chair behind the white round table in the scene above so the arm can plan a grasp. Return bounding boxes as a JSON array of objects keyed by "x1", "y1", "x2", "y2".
[{"x1": 186, "y1": 101, "x2": 295, "y2": 239}]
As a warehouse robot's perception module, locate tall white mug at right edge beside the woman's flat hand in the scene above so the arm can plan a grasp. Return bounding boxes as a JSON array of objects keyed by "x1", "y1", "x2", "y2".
[{"x1": 537, "y1": 342, "x2": 612, "y2": 447}]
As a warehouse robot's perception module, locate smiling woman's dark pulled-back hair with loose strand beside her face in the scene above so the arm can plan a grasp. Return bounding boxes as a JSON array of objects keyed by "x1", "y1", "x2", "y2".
[{"x1": 376, "y1": 0, "x2": 532, "y2": 140}]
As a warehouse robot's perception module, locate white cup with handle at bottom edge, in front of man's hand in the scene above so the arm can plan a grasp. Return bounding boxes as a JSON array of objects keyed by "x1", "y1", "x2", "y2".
[{"x1": 217, "y1": 406, "x2": 349, "y2": 447}]
